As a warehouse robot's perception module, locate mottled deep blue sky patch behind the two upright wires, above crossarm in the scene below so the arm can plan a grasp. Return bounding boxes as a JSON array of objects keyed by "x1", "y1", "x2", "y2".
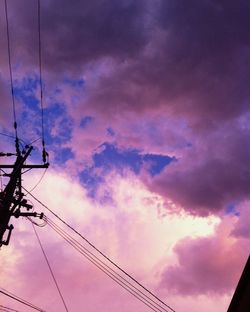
[{"x1": 11, "y1": 75, "x2": 73, "y2": 164}]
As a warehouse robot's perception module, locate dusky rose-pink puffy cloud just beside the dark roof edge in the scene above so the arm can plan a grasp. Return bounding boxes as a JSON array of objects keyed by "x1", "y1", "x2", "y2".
[{"x1": 161, "y1": 213, "x2": 249, "y2": 296}]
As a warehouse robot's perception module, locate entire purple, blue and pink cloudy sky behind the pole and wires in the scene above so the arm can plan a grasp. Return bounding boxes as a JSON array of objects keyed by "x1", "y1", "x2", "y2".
[{"x1": 0, "y1": 0, "x2": 250, "y2": 312}]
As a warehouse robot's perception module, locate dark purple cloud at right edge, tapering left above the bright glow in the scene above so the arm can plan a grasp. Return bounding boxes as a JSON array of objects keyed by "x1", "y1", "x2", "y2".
[{"x1": 148, "y1": 124, "x2": 250, "y2": 215}]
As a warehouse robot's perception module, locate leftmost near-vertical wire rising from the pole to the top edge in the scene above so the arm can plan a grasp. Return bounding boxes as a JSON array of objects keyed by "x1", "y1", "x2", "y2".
[{"x1": 4, "y1": 0, "x2": 18, "y2": 146}]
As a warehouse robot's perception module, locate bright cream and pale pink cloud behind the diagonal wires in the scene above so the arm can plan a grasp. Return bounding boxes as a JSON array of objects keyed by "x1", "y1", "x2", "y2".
[{"x1": 0, "y1": 172, "x2": 221, "y2": 312}]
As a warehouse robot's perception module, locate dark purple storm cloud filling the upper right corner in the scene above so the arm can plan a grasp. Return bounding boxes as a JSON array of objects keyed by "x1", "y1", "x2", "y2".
[{"x1": 86, "y1": 1, "x2": 250, "y2": 126}]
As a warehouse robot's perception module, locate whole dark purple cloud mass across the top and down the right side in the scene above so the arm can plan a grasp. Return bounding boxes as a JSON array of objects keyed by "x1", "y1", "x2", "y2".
[{"x1": 0, "y1": 0, "x2": 250, "y2": 213}]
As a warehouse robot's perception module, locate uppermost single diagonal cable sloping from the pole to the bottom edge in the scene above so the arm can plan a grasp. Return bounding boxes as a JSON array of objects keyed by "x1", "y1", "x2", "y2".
[{"x1": 23, "y1": 187, "x2": 175, "y2": 312}]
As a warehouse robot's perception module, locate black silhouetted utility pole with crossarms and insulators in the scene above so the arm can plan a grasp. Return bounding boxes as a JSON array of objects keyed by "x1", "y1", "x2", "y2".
[{"x1": 0, "y1": 139, "x2": 49, "y2": 247}]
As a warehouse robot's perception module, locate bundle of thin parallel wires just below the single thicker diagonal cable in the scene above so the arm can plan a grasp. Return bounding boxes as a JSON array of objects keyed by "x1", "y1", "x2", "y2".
[{"x1": 46, "y1": 217, "x2": 170, "y2": 312}]
